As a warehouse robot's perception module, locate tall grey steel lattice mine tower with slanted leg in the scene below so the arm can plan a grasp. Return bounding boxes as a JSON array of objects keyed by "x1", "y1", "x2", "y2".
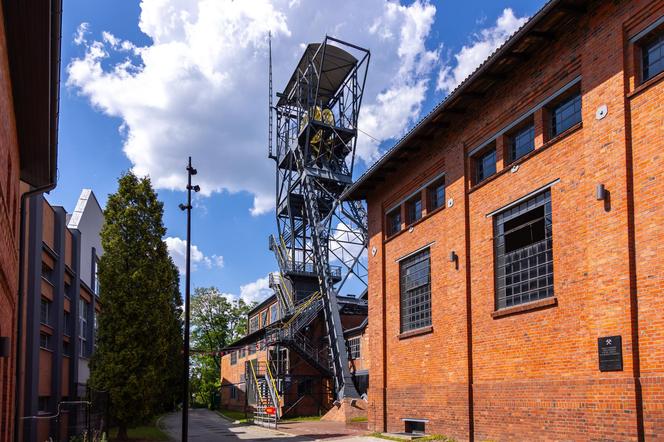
[{"x1": 269, "y1": 36, "x2": 370, "y2": 399}]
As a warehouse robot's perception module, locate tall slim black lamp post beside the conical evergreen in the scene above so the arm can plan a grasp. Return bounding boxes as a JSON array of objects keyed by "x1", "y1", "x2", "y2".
[{"x1": 179, "y1": 157, "x2": 201, "y2": 442}]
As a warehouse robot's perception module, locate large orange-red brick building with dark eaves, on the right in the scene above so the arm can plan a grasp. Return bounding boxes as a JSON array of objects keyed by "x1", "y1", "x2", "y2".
[{"x1": 346, "y1": 0, "x2": 664, "y2": 440}]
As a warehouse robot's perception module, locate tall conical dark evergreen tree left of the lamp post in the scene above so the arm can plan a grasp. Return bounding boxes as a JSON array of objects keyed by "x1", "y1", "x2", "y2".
[{"x1": 90, "y1": 172, "x2": 183, "y2": 440}]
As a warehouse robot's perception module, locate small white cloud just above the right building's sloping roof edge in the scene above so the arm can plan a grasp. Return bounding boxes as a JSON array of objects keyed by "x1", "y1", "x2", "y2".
[{"x1": 436, "y1": 8, "x2": 528, "y2": 93}]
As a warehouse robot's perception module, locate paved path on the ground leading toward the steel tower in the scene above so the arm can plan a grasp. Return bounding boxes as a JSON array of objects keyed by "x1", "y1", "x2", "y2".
[{"x1": 158, "y1": 409, "x2": 384, "y2": 442}]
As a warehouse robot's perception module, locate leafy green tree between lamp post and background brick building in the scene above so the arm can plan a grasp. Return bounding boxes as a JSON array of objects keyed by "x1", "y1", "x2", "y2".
[{"x1": 191, "y1": 287, "x2": 253, "y2": 408}]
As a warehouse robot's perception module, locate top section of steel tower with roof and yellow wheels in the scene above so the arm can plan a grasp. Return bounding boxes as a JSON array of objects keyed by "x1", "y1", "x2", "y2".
[{"x1": 276, "y1": 36, "x2": 371, "y2": 174}]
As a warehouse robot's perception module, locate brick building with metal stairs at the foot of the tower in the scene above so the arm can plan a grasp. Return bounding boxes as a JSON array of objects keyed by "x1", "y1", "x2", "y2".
[{"x1": 221, "y1": 288, "x2": 370, "y2": 417}]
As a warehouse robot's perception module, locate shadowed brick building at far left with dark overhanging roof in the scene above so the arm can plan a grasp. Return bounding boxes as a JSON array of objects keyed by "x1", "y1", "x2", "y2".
[{"x1": 0, "y1": 0, "x2": 61, "y2": 442}]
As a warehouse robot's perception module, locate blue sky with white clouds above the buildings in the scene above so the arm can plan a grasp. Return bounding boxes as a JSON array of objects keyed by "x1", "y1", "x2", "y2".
[{"x1": 48, "y1": 0, "x2": 544, "y2": 300}]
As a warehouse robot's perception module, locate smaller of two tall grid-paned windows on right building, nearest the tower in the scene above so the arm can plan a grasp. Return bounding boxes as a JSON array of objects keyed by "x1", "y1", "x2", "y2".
[{"x1": 400, "y1": 249, "x2": 431, "y2": 333}]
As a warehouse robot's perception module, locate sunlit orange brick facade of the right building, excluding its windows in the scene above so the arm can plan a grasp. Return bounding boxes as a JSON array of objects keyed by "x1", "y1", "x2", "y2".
[{"x1": 356, "y1": 1, "x2": 664, "y2": 440}]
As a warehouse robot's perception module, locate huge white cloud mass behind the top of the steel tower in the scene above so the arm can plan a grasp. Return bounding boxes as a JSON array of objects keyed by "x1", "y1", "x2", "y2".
[{"x1": 67, "y1": 0, "x2": 439, "y2": 214}]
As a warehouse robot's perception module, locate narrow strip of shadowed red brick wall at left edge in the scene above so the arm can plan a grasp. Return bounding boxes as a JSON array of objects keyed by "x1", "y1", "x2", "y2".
[{"x1": 0, "y1": 1, "x2": 19, "y2": 442}]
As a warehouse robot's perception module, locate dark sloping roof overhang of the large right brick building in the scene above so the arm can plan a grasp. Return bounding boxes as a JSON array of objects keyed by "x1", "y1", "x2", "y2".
[{"x1": 341, "y1": 0, "x2": 588, "y2": 200}]
